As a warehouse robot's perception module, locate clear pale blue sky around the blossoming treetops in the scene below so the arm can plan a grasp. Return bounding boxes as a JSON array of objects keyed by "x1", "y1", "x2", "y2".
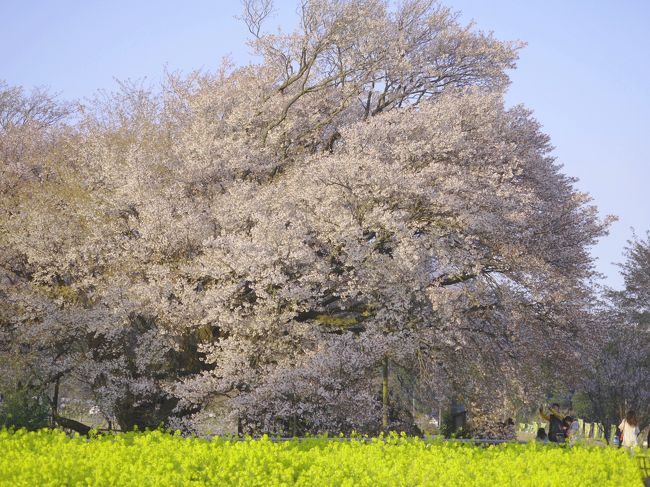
[{"x1": 0, "y1": 0, "x2": 650, "y2": 287}]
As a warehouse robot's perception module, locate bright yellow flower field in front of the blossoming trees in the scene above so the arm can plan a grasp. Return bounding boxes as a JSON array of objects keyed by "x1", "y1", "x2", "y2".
[{"x1": 0, "y1": 430, "x2": 642, "y2": 487}]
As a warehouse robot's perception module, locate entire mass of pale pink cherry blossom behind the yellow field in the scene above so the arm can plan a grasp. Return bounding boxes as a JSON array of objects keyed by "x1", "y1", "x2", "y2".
[{"x1": 0, "y1": 0, "x2": 608, "y2": 434}]
